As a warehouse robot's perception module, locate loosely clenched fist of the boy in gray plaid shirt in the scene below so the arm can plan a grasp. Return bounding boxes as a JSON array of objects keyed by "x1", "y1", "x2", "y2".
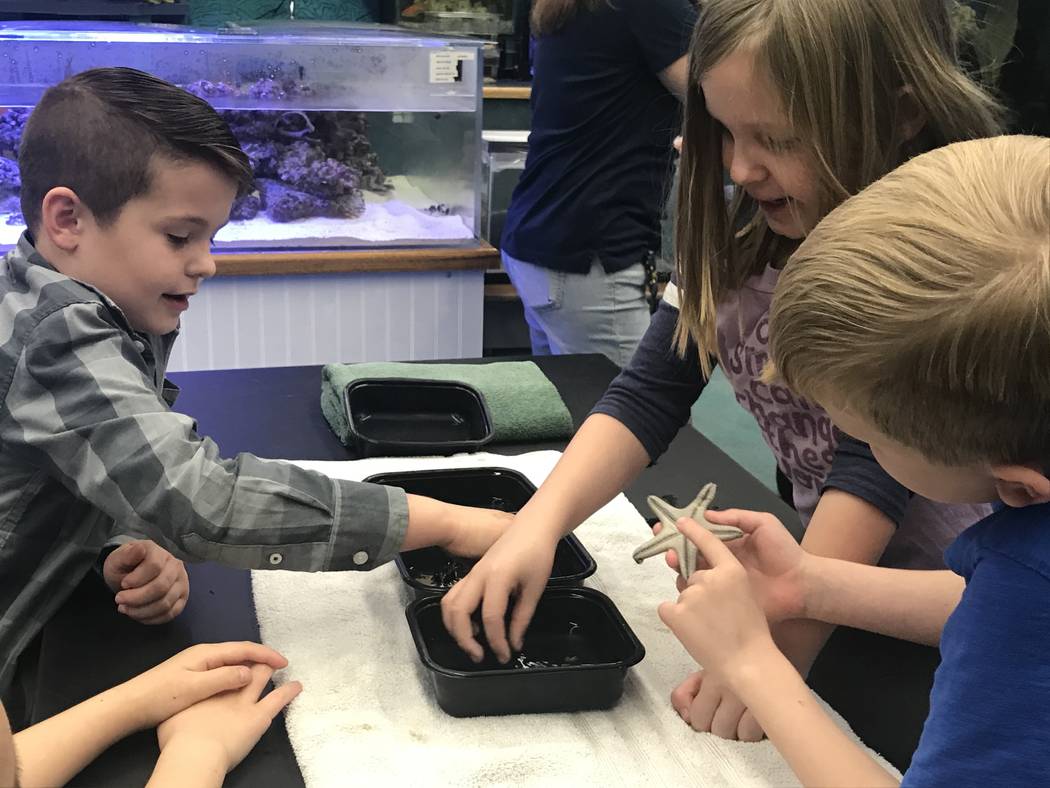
[{"x1": 102, "y1": 539, "x2": 190, "y2": 624}]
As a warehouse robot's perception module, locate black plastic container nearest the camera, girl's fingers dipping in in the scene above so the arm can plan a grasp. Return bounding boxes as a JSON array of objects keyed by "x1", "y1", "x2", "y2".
[{"x1": 405, "y1": 588, "x2": 646, "y2": 717}]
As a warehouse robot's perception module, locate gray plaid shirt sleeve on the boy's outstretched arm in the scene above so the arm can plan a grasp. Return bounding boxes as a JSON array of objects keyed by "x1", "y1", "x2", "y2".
[{"x1": 0, "y1": 303, "x2": 407, "y2": 571}]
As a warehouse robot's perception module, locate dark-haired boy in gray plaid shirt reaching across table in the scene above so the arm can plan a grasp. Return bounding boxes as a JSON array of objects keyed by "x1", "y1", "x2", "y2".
[{"x1": 0, "y1": 68, "x2": 508, "y2": 701}]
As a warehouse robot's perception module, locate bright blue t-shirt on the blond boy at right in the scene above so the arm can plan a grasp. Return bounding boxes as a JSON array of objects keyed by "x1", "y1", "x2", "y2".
[{"x1": 903, "y1": 504, "x2": 1050, "y2": 788}]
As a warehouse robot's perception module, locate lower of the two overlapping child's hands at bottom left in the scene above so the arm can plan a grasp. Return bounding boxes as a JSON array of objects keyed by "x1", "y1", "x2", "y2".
[{"x1": 156, "y1": 664, "x2": 302, "y2": 773}]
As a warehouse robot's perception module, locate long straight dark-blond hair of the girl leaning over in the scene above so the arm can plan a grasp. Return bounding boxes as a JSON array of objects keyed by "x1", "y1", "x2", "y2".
[{"x1": 675, "y1": 0, "x2": 1003, "y2": 373}]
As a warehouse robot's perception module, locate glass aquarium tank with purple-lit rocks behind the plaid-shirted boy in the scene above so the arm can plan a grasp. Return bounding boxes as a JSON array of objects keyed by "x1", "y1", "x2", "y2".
[{"x1": 0, "y1": 22, "x2": 482, "y2": 251}]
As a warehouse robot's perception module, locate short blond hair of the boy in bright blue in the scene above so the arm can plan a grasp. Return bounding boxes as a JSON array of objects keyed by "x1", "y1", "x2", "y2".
[{"x1": 770, "y1": 136, "x2": 1050, "y2": 464}]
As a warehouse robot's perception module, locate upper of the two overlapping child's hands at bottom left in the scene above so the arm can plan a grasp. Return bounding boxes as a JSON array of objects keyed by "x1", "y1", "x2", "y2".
[{"x1": 120, "y1": 641, "x2": 288, "y2": 730}]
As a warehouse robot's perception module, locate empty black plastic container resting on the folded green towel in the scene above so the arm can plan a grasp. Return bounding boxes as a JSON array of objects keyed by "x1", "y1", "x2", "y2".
[{"x1": 343, "y1": 377, "x2": 492, "y2": 457}]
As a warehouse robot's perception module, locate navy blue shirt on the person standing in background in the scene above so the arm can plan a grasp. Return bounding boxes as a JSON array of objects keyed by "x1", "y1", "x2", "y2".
[{"x1": 502, "y1": 0, "x2": 697, "y2": 273}]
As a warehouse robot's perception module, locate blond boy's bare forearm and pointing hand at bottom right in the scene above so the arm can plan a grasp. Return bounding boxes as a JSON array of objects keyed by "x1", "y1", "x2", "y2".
[{"x1": 659, "y1": 520, "x2": 898, "y2": 786}]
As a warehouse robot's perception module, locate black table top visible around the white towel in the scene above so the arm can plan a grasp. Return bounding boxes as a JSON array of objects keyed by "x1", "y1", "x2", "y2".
[{"x1": 24, "y1": 355, "x2": 928, "y2": 788}]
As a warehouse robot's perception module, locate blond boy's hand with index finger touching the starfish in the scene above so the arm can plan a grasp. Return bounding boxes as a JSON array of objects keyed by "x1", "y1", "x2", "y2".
[{"x1": 659, "y1": 518, "x2": 776, "y2": 679}]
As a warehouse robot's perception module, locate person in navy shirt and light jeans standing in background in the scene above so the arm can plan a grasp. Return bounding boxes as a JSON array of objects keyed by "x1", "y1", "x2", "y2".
[{"x1": 501, "y1": 0, "x2": 696, "y2": 367}]
